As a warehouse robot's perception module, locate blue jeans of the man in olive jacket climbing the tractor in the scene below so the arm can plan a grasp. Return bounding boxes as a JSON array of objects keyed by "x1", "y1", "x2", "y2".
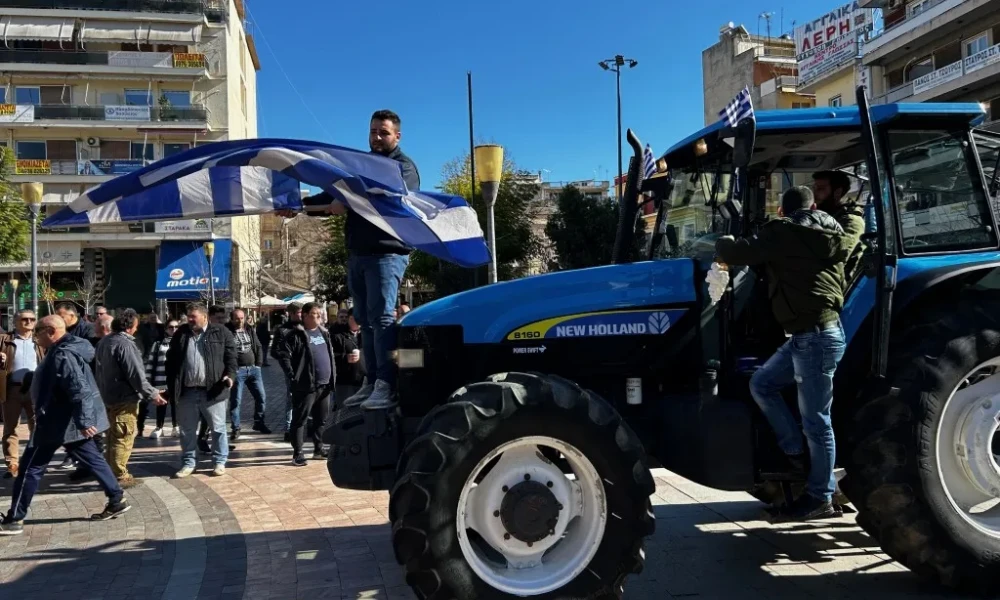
[{"x1": 750, "y1": 320, "x2": 846, "y2": 500}]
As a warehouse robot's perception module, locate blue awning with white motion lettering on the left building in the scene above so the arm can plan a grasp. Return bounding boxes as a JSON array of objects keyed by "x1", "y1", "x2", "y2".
[{"x1": 156, "y1": 240, "x2": 233, "y2": 301}]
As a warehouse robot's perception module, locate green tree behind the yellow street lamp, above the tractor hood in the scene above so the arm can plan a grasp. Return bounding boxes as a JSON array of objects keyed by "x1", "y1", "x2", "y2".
[{"x1": 407, "y1": 154, "x2": 542, "y2": 297}]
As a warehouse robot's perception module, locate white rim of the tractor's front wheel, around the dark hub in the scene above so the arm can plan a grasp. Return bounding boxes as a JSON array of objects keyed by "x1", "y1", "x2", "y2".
[{"x1": 456, "y1": 436, "x2": 608, "y2": 596}]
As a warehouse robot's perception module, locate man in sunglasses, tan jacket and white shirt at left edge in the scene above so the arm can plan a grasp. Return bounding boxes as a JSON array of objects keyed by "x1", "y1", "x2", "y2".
[{"x1": 0, "y1": 310, "x2": 45, "y2": 479}]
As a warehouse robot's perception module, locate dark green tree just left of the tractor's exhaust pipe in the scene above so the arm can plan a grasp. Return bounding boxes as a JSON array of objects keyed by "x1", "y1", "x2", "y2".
[{"x1": 545, "y1": 185, "x2": 646, "y2": 269}]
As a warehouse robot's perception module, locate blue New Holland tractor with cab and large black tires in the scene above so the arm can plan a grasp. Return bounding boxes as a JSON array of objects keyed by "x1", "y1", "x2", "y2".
[{"x1": 326, "y1": 88, "x2": 1000, "y2": 600}]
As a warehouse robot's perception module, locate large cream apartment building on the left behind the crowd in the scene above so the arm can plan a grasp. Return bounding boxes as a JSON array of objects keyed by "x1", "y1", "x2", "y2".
[{"x1": 0, "y1": 0, "x2": 260, "y2": 312}]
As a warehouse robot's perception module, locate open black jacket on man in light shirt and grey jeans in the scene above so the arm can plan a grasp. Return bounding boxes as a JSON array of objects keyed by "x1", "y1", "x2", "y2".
[{"x1": 167, "y1": 323, "x2": 236, "y2": 402}]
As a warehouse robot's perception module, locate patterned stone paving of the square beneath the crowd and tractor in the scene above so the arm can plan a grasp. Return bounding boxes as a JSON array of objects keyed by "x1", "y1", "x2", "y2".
[{"x1": 0, "y1": 366, "x2": 968, "y2": 600}]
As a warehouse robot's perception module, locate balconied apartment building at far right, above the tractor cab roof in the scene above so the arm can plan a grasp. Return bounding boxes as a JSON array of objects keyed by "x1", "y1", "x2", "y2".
[{"x1": 861, "y1": 0, "x2": 1000, "y2": 121}]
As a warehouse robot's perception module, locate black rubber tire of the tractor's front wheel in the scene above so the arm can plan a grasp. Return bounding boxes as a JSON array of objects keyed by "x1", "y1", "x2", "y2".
[{"x1": 389, "y1": 373, "x2": 655, "y2": 600}]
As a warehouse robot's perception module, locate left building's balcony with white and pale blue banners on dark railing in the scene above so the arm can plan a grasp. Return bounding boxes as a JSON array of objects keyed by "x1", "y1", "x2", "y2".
[{"x1": 6, "y1": 104, "x2": 208, "y2": 128}]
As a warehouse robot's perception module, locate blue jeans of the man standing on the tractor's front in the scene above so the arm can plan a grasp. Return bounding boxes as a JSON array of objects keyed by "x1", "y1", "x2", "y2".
[{"x1": 347, "y1": 254, "x2": 410, "y2": 387}]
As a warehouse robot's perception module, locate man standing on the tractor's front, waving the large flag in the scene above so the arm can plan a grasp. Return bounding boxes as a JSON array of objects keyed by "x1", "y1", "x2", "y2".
[{"x1": 296, "y1": 110, "x2": 420, "y2": 410}]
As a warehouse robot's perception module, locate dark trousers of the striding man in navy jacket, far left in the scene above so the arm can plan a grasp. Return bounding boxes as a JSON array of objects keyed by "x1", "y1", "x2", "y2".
[{"x1": 10, "y1": 439, "x2": 123, "y2": 521}]
